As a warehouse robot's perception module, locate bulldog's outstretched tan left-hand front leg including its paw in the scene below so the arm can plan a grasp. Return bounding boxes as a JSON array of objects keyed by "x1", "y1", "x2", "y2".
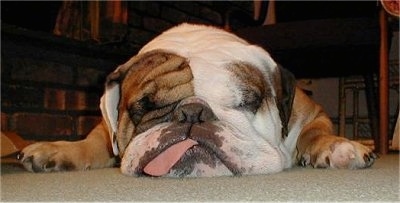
[{"x1": 19, "y1": 122, "x2": 115, "y2": 172}]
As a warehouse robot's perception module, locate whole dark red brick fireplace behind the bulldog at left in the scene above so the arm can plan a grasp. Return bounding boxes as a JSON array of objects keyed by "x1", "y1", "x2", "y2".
[{"x1": 1, "y1": 1, "x2": 252, "y2": 140}]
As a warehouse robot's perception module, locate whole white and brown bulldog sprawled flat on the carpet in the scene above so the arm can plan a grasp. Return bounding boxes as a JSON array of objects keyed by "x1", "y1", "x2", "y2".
[{"x1": 18, "y1": 24, "x2": 377, "y2": 177}]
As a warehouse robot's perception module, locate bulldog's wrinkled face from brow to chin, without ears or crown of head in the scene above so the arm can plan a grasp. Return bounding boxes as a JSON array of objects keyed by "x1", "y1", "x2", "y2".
[{"x1": 103, "y1": 51, "x2": 283, "y2": 177}]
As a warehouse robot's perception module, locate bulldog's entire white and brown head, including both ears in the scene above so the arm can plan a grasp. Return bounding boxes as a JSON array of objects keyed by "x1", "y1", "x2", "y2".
[{"x1": 101, "y1": 24, "x2": 294, "y2": 177}]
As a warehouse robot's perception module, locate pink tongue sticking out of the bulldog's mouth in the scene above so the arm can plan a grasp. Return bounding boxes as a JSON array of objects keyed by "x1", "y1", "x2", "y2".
[{"x1": 143, "y1": 139, "x2": 198, "y2": 176}]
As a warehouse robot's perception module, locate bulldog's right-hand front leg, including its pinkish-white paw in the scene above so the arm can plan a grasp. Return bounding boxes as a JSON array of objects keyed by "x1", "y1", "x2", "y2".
[{"x1": 297, "y1": 112, "x2": 377, "y2": 169}]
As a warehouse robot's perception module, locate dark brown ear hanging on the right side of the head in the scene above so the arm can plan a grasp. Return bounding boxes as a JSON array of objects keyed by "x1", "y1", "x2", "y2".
[{"x1": 277, "y1": 65, "x2": 296, "y2": 139}]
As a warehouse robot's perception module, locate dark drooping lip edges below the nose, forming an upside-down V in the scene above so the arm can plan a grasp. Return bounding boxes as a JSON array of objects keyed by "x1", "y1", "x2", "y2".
[{"x1": 136, "y1": 124, "x2": 242, "y2": 176}]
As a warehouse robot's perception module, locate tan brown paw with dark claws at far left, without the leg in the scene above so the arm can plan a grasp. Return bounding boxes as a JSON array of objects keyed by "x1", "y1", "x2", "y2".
[{"x1": 17, "y1": 142, "x2": 81, "y2": 172}]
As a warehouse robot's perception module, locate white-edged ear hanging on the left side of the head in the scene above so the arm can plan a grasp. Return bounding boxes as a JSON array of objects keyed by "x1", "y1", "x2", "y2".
[{"x1": 100, "y1": 65, "x2": 125, "y2": 155}]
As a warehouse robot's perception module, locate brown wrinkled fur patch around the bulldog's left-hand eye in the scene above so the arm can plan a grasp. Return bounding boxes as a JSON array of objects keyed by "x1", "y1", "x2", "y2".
[{"x1": 117, "y1": 50, "x2": 194, "y2": 155}]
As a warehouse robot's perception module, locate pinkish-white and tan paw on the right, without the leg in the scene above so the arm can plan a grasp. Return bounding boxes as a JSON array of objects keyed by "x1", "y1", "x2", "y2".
[{"x1": 299, "y1": 137, "x2": 378, "y2": 169}]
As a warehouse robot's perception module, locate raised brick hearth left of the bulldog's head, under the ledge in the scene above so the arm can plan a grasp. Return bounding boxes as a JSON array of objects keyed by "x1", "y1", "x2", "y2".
[{"x1": 1, "y1": 26, "x2": 130, "y2": 140}]
